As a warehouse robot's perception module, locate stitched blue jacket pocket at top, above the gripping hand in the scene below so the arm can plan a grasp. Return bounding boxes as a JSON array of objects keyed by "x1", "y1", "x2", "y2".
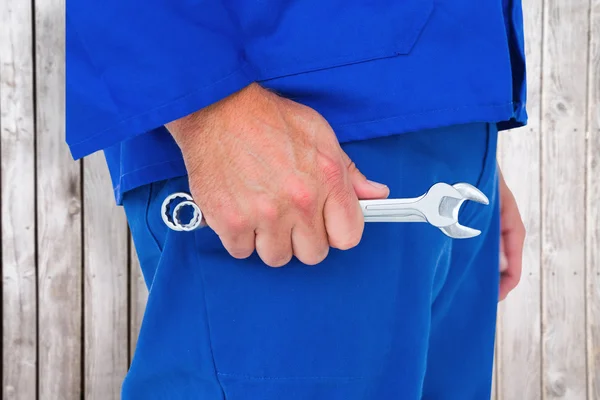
[{"x1": 241, "y1": 0, "x2": 434, "y2": 79}]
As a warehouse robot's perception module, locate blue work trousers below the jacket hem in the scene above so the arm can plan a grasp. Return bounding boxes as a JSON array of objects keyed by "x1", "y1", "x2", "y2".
[{"x1": 123, "y1": 123, "x2": 500, "y2": 400}]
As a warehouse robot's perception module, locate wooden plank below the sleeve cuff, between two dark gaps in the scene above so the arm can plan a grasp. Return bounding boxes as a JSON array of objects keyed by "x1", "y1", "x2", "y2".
[{"x1": 83, "y1": 153, "x2": 129, "y2": 400}]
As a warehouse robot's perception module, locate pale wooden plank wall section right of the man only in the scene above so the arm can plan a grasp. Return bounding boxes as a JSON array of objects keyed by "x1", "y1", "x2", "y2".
[{"x1": 494, "y1": 0, "x2": 600, "y2": 400}]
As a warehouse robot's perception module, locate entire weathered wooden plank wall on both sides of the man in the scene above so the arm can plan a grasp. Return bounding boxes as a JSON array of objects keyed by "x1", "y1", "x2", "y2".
[{"x1": 0, "y1": 0, "x2": 600, "y2": 400}]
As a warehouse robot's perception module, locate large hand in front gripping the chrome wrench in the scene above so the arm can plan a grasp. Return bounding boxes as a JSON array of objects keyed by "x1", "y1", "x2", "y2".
[{"x1": 167, "y1": 84, "x2": 389, "y2": 267}]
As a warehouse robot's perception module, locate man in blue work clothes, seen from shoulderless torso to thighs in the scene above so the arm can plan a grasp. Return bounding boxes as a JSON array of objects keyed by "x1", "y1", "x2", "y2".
[{"x1": 67, "y1": 0, "x2": 526, "y2": 400}]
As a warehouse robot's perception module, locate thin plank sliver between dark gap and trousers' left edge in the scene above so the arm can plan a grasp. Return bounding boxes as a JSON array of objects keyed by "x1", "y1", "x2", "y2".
[{"x1": 129, "y1": 238, "x2": 148, "y2": 360}]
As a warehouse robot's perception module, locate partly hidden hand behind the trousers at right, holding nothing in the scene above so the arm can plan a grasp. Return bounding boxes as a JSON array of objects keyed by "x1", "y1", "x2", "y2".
[{"x1": 499, "y1": 167, "x2": 525, "y2": 301}]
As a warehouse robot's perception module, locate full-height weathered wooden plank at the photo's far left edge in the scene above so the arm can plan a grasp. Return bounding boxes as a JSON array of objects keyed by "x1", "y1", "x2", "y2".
[{"x1": 0, "y1": 0, "x2": 37, "y2": 400}]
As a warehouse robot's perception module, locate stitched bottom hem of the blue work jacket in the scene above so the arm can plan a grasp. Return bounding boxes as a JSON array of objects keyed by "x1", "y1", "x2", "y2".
[{"x1": 114, "y1": 102, "x2": 527, "y2": 205}]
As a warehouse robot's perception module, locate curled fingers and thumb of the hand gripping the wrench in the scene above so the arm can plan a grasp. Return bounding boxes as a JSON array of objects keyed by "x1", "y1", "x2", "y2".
[{"x1": 209, "y1": 149, "x2": 389, "y2": 267}]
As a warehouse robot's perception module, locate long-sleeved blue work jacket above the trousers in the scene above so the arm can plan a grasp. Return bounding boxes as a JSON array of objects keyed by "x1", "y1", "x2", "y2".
[{"x1": 66, "y1": 0, "x2": 527, "y2": 202}]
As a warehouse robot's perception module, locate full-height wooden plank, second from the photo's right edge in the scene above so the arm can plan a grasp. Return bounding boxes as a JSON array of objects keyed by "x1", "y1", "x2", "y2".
[{"x1": 541, "y1": 0, "x2": 589, "y2": 400}]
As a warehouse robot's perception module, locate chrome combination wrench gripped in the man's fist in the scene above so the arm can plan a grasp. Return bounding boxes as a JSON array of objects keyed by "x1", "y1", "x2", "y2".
[{"x1": 161, "y1": 183, "x2": 489, "y2": 239}]
